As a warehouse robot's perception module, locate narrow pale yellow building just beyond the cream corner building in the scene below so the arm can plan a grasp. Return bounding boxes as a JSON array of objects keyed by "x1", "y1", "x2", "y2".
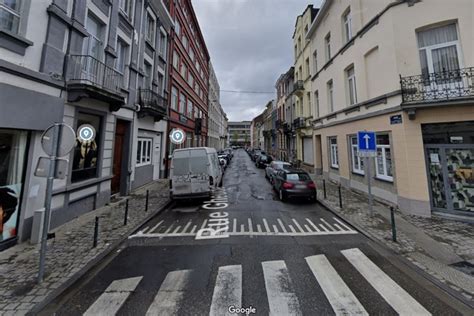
[{"x1": 293, "y1": 5, "x2": 318, "y2": 170}]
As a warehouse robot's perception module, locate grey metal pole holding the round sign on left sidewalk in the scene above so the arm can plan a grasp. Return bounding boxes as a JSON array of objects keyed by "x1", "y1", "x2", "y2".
[{"x1": 38, "y1": 123, "x2": 60, "y2": 283}]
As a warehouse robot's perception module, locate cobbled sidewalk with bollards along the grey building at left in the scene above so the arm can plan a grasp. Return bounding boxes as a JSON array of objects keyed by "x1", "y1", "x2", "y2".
[{"x1": 0, "y1": 179, "x2": 170, "y2": 315}]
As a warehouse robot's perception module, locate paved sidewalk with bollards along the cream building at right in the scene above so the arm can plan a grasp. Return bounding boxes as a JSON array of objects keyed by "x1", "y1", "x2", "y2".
[{"x1": 311, "y1": 175, "x2": 474, "y2": 306}]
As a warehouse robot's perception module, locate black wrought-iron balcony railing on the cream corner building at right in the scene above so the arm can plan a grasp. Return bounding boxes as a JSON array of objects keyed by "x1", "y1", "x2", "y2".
[{"x1": 400, "y1": 67, "x2": 474, "y2": 104}]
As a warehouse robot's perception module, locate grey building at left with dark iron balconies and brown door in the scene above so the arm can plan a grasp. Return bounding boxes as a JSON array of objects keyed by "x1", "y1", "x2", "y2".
[{"x1": 0, "y1": 0, "x2": 173, "y2": 249}]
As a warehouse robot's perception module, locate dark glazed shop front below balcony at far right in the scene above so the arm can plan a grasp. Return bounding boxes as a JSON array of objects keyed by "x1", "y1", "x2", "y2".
[{"x1": 422, "y1": 121, "x2": 474, "y2": 217}]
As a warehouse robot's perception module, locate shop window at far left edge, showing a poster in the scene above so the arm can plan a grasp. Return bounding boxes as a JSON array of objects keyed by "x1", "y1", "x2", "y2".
[{"x1": 0, "y1": 129, "x2": 28, "y2": 243}]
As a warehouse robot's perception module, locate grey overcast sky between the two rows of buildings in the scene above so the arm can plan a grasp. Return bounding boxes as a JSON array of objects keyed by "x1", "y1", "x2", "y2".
[{"x1": 192, "y1": 0, "x2": 321, "y2": 121}]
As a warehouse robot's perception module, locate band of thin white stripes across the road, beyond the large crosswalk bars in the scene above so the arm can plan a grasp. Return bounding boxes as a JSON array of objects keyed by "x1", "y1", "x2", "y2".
[{"x1": 129, "y1": 217, "x2": 357, "y2": 239}]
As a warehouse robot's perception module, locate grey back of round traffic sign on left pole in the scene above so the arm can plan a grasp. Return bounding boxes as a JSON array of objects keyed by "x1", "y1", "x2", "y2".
[{"x1": 41, "y1": 123, "x2": 76, "y2": 157}]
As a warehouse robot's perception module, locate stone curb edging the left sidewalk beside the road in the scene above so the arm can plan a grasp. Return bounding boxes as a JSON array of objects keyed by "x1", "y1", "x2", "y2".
[{"x1": 26, "y1": 198, "x2": 173, "y2": 315}]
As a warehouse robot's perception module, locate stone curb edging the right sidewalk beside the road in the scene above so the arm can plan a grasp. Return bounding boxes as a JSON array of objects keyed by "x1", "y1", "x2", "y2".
[{"x1": 318, "y1": 199, "x2": 474, "y2": 309}]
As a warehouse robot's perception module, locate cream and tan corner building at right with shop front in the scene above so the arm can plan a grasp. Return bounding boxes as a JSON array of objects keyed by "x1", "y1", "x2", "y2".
[{"x1": 306, "y1": 0, "x2": 474, "y2": 217}]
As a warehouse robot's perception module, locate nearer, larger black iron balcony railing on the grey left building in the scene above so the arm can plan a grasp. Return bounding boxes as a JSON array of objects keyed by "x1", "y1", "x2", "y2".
[{"x1": 66, "y1": 55, "x2": 123, "y2": 93}]
